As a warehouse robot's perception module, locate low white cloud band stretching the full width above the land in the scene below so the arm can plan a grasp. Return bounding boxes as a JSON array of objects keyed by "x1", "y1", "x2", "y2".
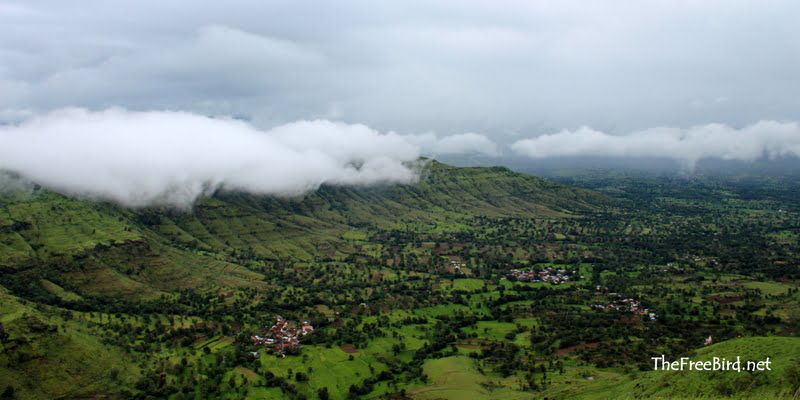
[{"x1": 0, "y1": 108, "x2": 800, "y2": 207}]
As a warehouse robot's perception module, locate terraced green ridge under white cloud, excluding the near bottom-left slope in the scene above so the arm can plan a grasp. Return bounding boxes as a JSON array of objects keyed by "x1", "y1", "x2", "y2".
[{"x1": 0, "y1": 161, "x2": 611, "y2": 299}]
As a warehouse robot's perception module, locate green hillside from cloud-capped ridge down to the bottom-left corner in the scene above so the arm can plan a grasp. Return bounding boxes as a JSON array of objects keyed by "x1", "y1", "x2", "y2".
[{"x1": 0, "y1": 161, "x2": 610, "y2": 398}]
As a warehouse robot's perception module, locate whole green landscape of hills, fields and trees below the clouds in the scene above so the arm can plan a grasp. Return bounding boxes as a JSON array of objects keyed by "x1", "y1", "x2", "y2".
[{"x1": 0, "y1": 162, "x2": 800, "y2": 399}]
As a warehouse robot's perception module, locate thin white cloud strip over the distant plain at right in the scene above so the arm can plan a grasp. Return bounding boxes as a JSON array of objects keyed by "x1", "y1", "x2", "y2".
[{"x1": 511, "y1": 121, "x2": 800, "y2": 169}]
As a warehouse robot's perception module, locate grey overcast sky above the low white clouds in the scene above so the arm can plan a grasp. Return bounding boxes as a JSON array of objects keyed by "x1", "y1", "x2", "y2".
[{"x1": 0, "y1": 0, "x2": 800, "y2": 134}]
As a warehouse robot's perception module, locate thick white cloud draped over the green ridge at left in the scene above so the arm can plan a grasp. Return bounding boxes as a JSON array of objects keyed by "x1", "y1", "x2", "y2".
[{"x1": 0, "y1": 109, "x2": 493, "y2": 207}]
